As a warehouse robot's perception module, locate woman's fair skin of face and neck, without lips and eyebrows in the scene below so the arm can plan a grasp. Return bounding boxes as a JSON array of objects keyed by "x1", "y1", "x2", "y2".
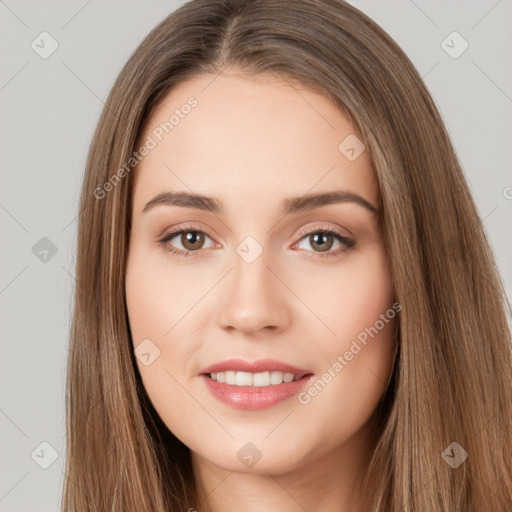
[{"x1": 126, "y1": 69, "x2": 396, "y2": 512}]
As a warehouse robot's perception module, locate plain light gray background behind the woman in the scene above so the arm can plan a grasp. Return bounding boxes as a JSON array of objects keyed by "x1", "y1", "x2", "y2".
[{"x1": 0, "y1": 0, "x2": 512, "y2": 512}]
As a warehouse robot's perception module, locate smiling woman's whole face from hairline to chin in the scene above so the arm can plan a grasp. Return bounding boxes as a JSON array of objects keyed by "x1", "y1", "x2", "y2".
[{"x1": 126, "y1": 71, "x2": 396, "y2": 474}]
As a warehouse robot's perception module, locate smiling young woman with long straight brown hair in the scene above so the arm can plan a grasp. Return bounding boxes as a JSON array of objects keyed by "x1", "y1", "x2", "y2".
[{"x1": 62, "y1": 0, "x2": 512, "y2": 512}]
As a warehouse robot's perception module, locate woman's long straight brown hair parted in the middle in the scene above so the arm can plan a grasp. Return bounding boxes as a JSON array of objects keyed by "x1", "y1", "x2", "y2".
[{"x1": 62, "y1": 0, "x2": 512, "y2": 512}]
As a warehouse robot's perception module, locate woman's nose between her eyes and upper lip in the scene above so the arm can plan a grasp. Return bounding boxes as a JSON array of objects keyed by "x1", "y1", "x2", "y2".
[{"x1": 217, "y1": 243, "x2": 290, "y2": 336}]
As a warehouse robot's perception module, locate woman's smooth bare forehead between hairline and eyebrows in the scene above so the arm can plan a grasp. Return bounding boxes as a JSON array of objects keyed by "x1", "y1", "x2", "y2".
[{"x1": 134, "y1": 71, "x2": 379, "y2": 215}]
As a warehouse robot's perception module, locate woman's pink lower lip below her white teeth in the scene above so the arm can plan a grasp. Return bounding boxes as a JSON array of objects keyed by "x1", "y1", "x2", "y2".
[{"x1": 201, "y1": 375, "x2": 313, "y2": 411}]
